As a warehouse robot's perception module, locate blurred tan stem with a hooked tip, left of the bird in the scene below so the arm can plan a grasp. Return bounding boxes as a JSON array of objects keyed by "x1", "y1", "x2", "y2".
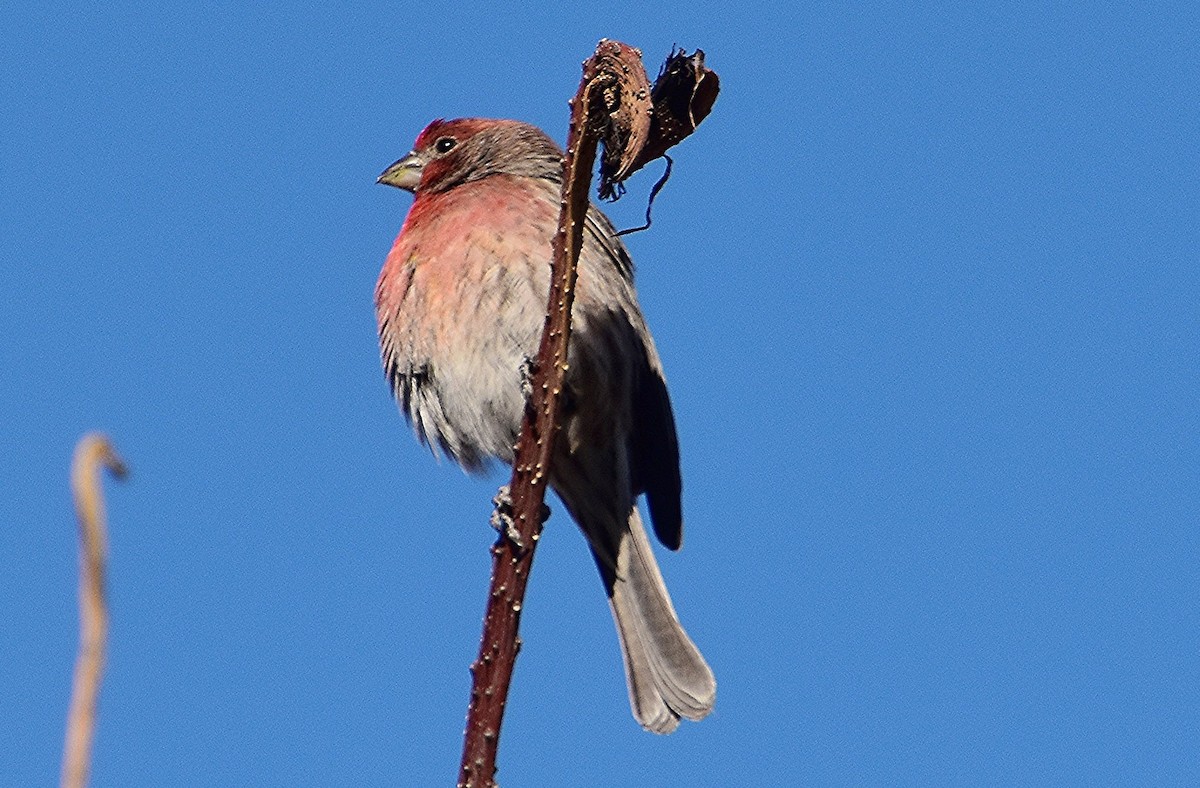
[{"x1": 61, "y1": 433, "x2": 125, "y2": 788}]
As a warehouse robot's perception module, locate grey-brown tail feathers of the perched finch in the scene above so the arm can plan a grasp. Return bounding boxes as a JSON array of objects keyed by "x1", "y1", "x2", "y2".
[{"x1": 596, "y1": 507, "x2": 716, "y2": 733}]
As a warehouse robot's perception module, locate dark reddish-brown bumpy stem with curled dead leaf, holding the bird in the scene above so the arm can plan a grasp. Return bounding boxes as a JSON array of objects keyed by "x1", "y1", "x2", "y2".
[{"x1": 458, "y1": 41, "x2": 716, "y2": 788}]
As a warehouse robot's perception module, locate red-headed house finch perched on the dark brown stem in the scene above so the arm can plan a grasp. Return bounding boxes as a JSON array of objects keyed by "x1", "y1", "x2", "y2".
[{"x1": 376, "y1": 119, "x2": 716, "y2": 733}]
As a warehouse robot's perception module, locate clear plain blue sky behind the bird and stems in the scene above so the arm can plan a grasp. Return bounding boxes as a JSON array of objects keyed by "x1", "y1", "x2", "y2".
[{"x1": 0, "y1": 2, "x2": 1200, "y2": 788}]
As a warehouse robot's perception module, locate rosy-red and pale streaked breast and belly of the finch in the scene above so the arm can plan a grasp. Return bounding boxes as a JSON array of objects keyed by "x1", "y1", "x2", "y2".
[{"x1": 376, "y1": 178, "x2": 557, "y2": 468}]
